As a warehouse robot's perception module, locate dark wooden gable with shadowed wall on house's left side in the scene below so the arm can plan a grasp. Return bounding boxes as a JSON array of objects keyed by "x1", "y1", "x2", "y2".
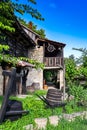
[{"x1": 0, "y1": 20, "x2": 36, "y2": 57}]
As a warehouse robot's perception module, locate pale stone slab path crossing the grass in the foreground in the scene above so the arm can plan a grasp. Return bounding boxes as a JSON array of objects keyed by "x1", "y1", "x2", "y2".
[{"x1": 24, "y1": 111, "x2": 87, "y2": 130}]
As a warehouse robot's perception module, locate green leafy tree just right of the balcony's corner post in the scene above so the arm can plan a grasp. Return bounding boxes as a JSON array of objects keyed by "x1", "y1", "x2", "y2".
[{"x1": 65, "y1": 48, "x2": 87, "y2": 87}]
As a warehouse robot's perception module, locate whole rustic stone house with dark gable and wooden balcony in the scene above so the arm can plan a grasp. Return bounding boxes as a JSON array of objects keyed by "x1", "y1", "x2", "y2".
[{"x1": 0, "y1": 21, "x2": 65, "y2": 95}]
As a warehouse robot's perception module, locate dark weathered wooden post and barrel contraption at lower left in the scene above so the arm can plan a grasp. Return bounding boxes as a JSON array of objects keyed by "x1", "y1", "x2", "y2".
[{"x1": 0, "y1": 68, "x2": 29, "y2": 124}]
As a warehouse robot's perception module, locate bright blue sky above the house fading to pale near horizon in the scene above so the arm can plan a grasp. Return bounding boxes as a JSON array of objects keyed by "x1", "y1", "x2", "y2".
[{"x1": 15, "y1": 0, "x2": 87, "y2": 57}]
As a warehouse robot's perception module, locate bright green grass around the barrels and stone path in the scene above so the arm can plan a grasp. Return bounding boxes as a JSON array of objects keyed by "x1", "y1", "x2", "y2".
[{"x1": 0, "y1": 90, "x2": 87, "y2": 130}]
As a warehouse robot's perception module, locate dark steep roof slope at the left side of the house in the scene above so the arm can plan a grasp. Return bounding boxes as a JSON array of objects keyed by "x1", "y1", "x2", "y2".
[{"x1": 3, "y1": 19, "x2": 36, "y2": 46}]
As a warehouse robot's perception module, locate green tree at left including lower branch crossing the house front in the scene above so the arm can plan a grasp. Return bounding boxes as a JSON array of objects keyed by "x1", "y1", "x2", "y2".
[{"x1": 0, "y1": 0, "x2": 44, "y2": 68}]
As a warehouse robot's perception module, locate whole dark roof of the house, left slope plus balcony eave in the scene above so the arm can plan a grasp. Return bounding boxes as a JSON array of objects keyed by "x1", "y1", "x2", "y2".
[{"x1": 2, "y1": 18, "x2": 66, "y2": 47}]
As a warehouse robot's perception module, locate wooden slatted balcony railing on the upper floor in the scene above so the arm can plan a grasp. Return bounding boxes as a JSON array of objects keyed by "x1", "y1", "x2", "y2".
[{"x1": 44, "y1": 57, "x2": 63, "y2": 67}]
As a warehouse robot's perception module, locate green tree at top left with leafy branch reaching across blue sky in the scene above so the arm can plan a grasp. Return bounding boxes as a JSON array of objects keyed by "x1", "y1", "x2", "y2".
[{"x1": 0, "y1": 0, "x2": 44, "y2": 31}]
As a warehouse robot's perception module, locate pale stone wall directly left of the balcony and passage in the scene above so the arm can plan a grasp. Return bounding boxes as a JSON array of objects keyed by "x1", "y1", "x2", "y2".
[{"x1": 26, "y1": 46, "x2": 43, "y2": 89}]
